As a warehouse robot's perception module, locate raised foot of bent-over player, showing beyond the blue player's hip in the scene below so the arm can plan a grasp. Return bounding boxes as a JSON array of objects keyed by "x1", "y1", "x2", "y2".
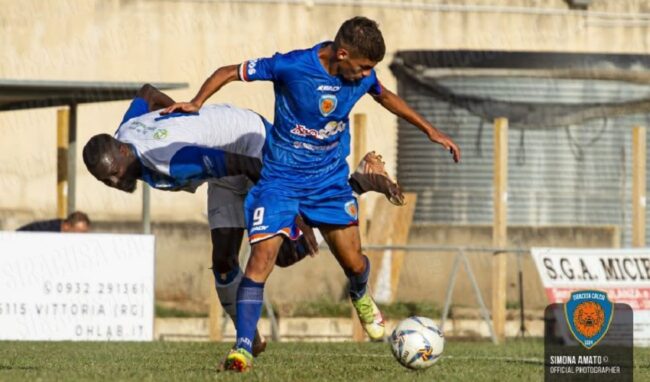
[{"x1": 349, "y1": 151, "x2": 405, "y2": 206}]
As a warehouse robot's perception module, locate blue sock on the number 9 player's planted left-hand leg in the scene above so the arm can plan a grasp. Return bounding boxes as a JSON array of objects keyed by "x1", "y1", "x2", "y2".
[{"x1": 235, "y1": 276, "x2": 264, "y2": 353}]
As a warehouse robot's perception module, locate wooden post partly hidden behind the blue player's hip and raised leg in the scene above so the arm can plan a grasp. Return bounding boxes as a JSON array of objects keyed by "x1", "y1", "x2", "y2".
[{"x1": 352, "y1": 114, "x2": 368, "y2": 342}]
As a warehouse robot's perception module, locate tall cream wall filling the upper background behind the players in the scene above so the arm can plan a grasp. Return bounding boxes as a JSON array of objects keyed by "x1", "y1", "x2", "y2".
[{"x1": 0, "y1": 0, "x2": 650, "y2": 221}]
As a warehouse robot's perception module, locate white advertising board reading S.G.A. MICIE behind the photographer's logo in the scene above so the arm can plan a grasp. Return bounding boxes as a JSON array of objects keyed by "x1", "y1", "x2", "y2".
[{"x1": 531, "y1": 248, "x2": 650, "y2": 346}]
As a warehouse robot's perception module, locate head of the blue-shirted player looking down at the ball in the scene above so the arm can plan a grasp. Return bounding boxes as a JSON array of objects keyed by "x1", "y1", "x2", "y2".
[{"x1": 332, "y1": 16, "x2": 386, "y2": 81}]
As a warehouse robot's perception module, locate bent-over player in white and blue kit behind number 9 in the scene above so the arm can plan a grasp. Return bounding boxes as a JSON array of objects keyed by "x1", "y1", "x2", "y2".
[{"x1": 83, "y1": 85, "x2": 403, "y2": 355}]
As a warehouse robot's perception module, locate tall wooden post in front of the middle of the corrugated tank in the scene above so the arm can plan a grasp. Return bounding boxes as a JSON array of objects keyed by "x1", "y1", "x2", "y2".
[{"x1": 492, "y1": 118, "x2": 508, "y2": 342}]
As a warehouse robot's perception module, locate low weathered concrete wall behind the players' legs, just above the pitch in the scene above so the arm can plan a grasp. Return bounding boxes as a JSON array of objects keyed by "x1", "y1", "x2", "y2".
[{"x1": 10, "y1": 221, "x2": 619, "y2": 309}]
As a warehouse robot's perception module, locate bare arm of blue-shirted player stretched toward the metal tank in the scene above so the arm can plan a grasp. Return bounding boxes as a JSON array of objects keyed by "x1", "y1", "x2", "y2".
[{"x1": 373, "y1": 86, "x2": 460, "y2": 162}]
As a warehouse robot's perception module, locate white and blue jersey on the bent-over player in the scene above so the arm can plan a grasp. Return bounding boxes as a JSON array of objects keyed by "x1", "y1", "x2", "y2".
[{"x1": 115, "y1": 104, "x2": 270, "y2": 192}]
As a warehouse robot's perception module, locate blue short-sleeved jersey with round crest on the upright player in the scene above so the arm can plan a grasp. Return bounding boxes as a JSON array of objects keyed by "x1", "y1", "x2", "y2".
[{"x1": 239, "y1": 42, "x2": 381, "y2": 194}]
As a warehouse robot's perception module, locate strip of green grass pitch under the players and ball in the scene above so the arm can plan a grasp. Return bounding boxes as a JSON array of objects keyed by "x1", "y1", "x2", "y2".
[{"x1": 0, "y1": 340, "x2": 650, "y2": 382}]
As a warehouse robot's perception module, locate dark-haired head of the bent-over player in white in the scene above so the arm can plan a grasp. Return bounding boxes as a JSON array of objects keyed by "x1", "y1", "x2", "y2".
[{"x1": 83, "y1": 134, "x2": 141, "y2": 192}]
